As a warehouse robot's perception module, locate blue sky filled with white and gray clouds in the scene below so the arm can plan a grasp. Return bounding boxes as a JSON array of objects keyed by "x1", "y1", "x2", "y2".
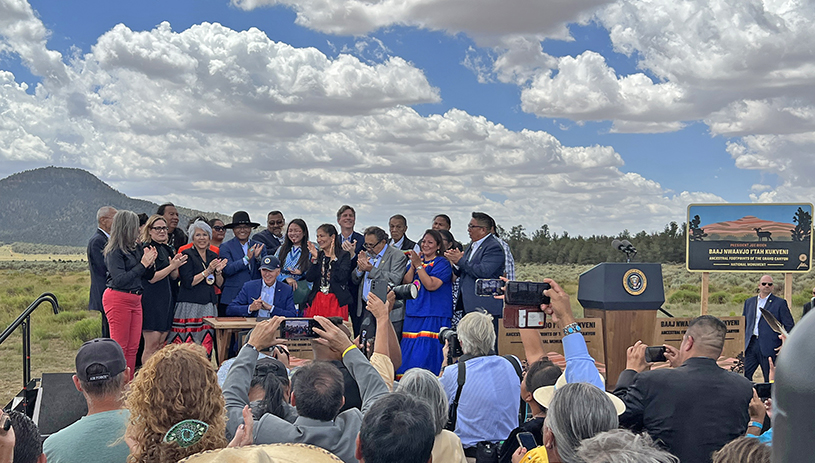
[{"x1": 0, "y1": 0, "x2": 815, "y2": 238}]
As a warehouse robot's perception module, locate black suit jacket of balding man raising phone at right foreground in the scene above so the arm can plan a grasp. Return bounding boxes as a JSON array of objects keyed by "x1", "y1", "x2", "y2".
[{"x1": 614, "y1": 357, "x2": 753, "y2": 463}]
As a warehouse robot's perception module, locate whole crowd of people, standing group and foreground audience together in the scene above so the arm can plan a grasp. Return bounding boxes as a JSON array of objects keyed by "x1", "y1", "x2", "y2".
[{"x1": 0, "y1": 204, "x2": 804, "y2": 463}]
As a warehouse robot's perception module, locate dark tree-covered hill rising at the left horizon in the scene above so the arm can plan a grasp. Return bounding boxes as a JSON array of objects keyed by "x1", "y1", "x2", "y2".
[{"x1": 0, "y1": 166, "x2": 230, "y2": 246}]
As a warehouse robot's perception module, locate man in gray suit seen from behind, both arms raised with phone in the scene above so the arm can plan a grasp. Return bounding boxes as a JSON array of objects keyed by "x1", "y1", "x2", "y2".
[{"x1": 224, "y1": 316, "x2": 388, "y2": 463}]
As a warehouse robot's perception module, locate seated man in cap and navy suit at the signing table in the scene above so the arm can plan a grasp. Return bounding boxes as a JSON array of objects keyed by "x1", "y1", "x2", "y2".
[{"x1": 226, "y1": 256, "x2": 297, "y2": 317}]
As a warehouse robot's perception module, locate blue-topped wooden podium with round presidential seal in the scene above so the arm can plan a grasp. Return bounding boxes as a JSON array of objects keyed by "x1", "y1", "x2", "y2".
[{"x1": 577, "y1": 262, "x2": 665, "y2": 390}]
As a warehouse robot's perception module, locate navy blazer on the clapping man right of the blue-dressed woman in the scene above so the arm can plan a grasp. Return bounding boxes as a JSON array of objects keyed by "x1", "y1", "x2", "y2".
[{"x1": 453, "y1": 235, "x2": 506, "y2": 318}]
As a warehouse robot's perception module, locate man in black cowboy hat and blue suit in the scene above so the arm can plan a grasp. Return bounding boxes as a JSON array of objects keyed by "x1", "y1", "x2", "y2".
[{"x1": 218, "y1": 211, "x2": 266, "y2": 317}]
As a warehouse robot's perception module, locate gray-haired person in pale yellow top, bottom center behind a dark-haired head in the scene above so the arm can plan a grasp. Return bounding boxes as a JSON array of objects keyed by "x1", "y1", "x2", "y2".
[{"x1": 397, "y1": 368, "x2": 467, "y2": 463}]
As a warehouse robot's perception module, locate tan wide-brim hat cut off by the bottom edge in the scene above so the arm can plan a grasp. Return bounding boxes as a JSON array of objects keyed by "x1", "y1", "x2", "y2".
[{"x1": 178, "y1": 444, "x2": 342, "y2": 463}]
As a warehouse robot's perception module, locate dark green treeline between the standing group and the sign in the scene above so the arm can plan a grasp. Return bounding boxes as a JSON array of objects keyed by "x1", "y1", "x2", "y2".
[{"x1": 497, "y1": 222, "x2": 687, "y2": 264}]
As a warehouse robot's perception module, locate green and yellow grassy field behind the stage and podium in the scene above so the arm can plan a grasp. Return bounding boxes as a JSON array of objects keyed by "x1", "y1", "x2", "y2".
[{"x1": 0, "y1": 260, "x2": 815, "y2": 405}]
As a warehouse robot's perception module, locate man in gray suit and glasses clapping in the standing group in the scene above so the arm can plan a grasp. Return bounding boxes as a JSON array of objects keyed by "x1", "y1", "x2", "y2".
[{"x1": 351, "y1": 227, "x2": 408, "y2": 339}]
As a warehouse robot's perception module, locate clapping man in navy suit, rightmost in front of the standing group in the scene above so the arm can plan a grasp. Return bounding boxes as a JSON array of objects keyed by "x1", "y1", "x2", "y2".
[{"x1": 444, "y1": 212, "x2": 505, "y2": 339}]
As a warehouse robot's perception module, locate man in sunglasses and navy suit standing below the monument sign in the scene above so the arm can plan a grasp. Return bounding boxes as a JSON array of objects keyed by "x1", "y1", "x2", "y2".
[{"x1": 742, "y1": 275, "x2": 795, "y2": 382}]
